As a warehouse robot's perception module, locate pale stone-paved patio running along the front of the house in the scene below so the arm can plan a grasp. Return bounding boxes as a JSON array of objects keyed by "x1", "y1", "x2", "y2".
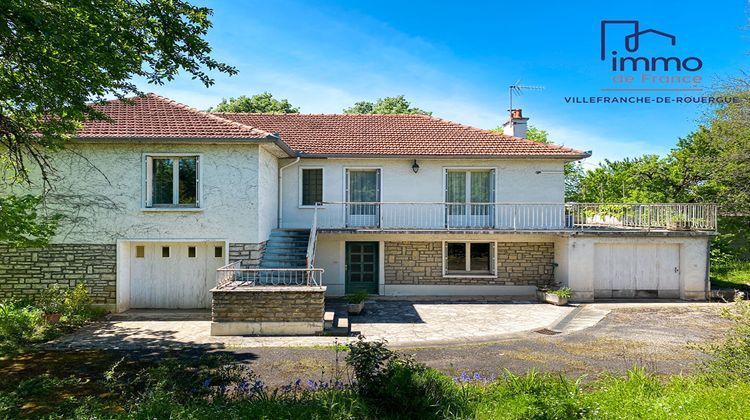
[{"x1": 48, "y1": 300, "x2": 575, "y2": 349}]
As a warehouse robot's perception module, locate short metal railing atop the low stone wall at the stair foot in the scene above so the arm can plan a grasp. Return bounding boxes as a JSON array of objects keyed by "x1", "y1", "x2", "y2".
[{"x1": 216, "y1": 261, "x2": 324, "y2": 289}]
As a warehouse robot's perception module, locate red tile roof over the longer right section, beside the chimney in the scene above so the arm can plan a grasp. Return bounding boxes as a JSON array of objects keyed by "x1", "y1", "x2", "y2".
[{"x1": 214, "y1": 113, "x2": 587, "y2": 160}]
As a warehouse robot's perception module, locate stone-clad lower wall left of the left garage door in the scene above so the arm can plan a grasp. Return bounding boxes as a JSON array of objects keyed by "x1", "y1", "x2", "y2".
[{"x1": 0, "y1": 244, "x2": 117, "y2": 304}]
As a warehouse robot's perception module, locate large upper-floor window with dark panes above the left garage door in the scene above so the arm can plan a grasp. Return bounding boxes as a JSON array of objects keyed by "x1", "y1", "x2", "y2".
[{"x1": 146, "y1": 156, "x2": 200, "y2": 208}]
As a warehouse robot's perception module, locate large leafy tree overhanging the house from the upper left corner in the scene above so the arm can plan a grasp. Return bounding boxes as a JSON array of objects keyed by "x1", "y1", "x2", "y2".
[{"x1": 0, "y1": 0, "x2": 237, "y2": 246}]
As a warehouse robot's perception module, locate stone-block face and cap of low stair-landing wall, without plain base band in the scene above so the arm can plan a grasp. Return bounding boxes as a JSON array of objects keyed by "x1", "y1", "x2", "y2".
[{"x1": 211, "y1": 286, "x2": 325, "y2": 325}]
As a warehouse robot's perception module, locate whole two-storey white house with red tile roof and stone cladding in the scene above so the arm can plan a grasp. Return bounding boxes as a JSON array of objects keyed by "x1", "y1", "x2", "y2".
[{"x1": 0, "y1": 94, "x2": 716, "y2": 328}]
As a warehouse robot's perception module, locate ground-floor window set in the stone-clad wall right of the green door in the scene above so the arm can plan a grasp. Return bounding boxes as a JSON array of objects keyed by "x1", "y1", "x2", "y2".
[{"x1": 444, "y1": 242, "x2": 495, "y2": 275}]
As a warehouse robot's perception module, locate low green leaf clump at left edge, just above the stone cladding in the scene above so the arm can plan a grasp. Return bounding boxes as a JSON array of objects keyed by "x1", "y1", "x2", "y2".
[{"x1": 0, "y1": 195, "x2": 61, "y2": 247}]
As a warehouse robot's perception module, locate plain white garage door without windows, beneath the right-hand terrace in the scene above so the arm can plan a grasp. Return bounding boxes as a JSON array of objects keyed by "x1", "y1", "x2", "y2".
[{"x1": 594, "y1": 243, "x2": 680, "y2": 298}]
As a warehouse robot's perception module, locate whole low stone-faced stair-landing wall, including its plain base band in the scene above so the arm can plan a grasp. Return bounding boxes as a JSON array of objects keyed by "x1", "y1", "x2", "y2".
[{"x1": 211, "y1": 285, "x2": 326, "y2": 335}]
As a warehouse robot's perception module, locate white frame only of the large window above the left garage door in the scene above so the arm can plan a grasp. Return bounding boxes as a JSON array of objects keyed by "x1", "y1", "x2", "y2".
[{"x1": 141, "y1": 153, "x2": 204, "y2": 212}]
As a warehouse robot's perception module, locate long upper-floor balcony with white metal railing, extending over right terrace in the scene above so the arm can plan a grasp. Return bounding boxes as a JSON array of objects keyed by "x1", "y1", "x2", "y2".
[{"x1": 315, "y1": 202, "x2": 717, "y2": 232}]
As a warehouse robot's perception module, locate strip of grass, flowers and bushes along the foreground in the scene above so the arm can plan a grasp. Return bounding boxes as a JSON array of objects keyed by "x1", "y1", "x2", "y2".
[{"x1": 0, "y1": 299, "x2": 750, "y2": 419}]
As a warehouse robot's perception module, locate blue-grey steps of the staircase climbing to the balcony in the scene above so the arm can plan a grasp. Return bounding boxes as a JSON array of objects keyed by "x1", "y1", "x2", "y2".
[{"x1": 260, "y1": 229, "x2": 310, "y2": 268}]
